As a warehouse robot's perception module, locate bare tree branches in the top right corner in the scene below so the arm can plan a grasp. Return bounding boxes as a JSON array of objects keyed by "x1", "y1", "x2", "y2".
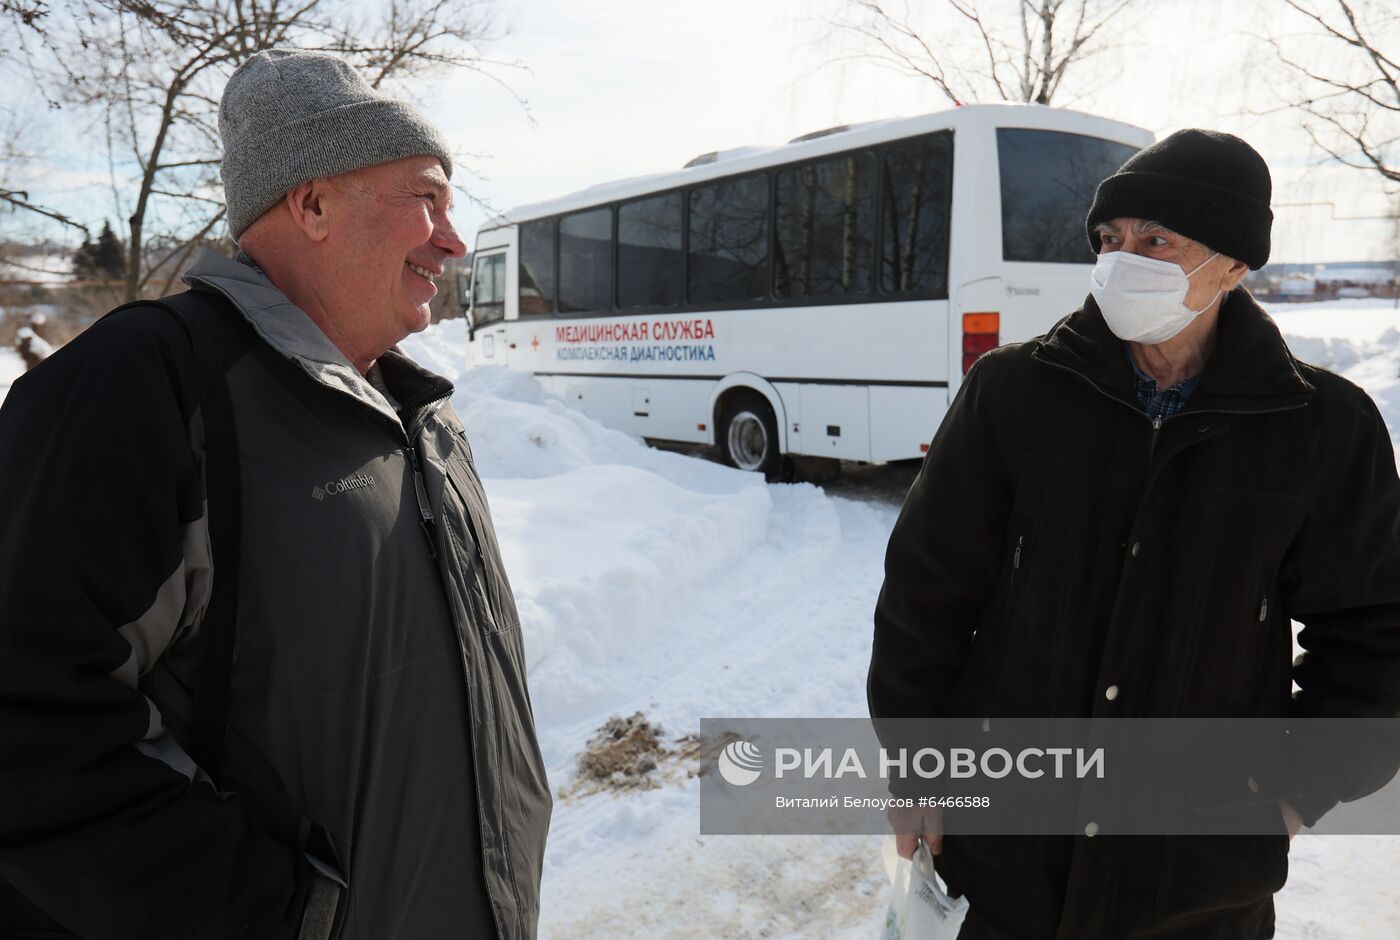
[{"x1": 1268, "y1": 0, "x2": 1400, "y2": 184}]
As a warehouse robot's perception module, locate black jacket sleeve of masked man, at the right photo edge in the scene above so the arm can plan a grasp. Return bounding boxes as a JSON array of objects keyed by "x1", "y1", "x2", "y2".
[{"x1": 1282, "y1": 389, "x2": 1400, "y2": 831}]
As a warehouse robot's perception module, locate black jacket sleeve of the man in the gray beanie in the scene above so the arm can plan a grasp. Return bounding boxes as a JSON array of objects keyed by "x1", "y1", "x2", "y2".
[{"x1": 0, "y1": 308, "x2": 300, "y2": 940}]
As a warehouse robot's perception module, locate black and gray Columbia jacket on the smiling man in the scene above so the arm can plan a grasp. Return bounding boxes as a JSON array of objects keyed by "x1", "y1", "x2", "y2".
[{"x1": 0, "y1": 252, "x2": 550, "y2": 940}]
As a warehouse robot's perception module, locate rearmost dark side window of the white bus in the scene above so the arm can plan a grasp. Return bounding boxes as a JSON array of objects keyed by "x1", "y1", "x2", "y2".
[{"x1": 879, "y1": 132, "x2": 953, "y2": 298}]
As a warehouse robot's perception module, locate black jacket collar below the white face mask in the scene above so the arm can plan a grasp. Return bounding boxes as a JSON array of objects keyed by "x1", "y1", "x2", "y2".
[{"x1": 1032, "y1": 287, "x2": 1315, "y2": 413}]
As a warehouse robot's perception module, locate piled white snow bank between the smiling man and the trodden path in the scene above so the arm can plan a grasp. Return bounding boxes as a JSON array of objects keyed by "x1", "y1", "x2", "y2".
[{"x1": 402, "y1": 327, "x2": 784, "y2": 745}]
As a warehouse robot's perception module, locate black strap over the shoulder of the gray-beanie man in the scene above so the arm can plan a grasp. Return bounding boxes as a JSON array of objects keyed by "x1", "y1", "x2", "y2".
[{"x1": 112, "y1": 290, "x2": 248, "y2": 782}]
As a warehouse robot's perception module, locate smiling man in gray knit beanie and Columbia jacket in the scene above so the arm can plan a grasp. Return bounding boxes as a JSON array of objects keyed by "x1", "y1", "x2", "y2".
[{"x1": 0, "y1": 49, "x2": 550, "y2": 940}]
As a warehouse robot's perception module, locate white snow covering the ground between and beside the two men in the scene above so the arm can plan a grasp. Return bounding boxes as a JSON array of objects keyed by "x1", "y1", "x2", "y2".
[{"x1": 403, "y1": 301, "x2": 1400, "y2": 940}]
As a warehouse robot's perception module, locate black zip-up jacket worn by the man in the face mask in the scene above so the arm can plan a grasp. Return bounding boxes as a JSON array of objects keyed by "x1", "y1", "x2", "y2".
[{"x1": 868, "y1": 289, "x2": 1400, "y2": 940}]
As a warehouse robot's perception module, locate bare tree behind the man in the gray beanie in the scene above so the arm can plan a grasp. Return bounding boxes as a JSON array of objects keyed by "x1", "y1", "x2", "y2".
[{"x1": 46, "y1": 0, "x2": 526, "y2": 300}]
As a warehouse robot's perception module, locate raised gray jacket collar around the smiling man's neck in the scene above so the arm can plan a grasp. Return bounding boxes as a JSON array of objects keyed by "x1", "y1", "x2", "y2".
[{"x1": 181, "y1": 248, "x2": 452, "y2": 423}]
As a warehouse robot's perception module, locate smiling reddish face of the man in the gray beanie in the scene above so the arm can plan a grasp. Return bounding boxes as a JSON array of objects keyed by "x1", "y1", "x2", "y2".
[{"x1": 332, "y1": 157, "x2": 466, "y2": 349}]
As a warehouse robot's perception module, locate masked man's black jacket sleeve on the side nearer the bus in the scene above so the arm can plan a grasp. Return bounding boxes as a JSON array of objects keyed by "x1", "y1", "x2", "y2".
[{"x1": 867, "y1": 352, "x2": 1011, "y2": 747}]
